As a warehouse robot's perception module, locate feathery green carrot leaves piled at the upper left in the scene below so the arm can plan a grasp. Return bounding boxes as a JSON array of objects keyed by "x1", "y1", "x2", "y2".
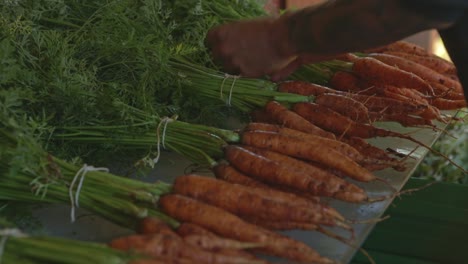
[{"x1": 0, "y1": 0, "x2": 265, "y2": 162}]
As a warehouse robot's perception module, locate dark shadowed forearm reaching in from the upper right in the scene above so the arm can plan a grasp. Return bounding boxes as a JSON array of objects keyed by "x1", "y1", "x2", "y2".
[{"x1": 285, "y1": 0, "x2": 453, "y2": 55}]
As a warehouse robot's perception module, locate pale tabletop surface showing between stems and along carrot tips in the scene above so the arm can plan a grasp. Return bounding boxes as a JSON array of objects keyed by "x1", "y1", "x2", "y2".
[{"x1": 34, "y1": 118, "x2": 445, "y2": 263}]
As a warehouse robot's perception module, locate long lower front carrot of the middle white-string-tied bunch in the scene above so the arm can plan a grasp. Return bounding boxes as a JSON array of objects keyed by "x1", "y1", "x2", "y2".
[{"x1": 225, "y1": 146, "x2": 367, "y2": 202}]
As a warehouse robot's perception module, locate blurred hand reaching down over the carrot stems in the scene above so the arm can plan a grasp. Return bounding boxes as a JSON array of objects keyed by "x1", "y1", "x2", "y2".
[{"x1": 206, "y1": 18, "x2": 299, "y2": 79}]
